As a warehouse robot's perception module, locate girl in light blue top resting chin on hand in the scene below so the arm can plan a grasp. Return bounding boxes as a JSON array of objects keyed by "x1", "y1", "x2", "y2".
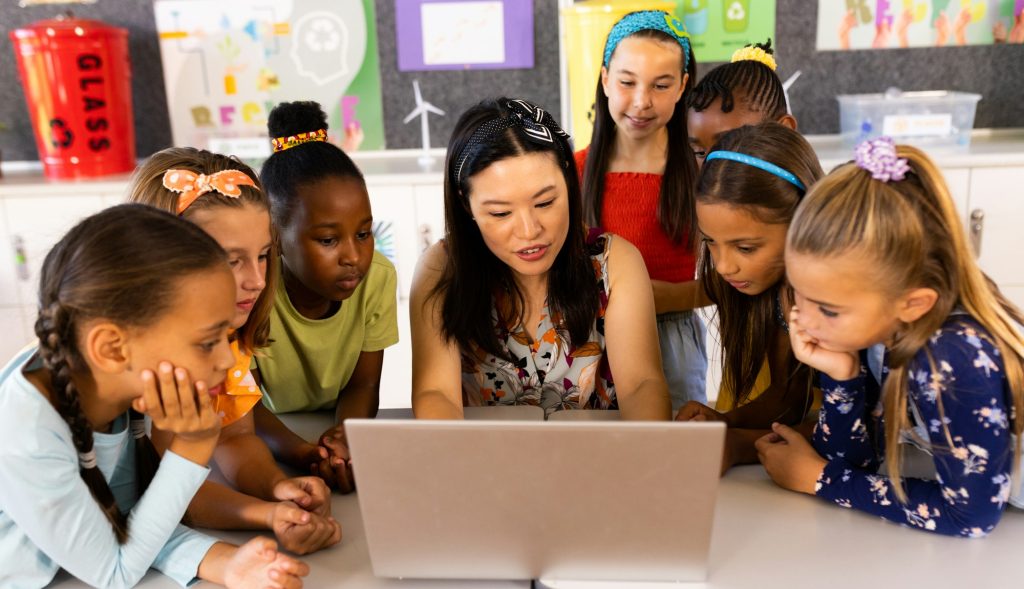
[{"x1": 0, "y1": 205, "x2": 308, "y2": 588}]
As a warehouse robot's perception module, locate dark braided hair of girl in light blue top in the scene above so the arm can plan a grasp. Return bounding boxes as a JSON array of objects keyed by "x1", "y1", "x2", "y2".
[{"x1": 35, "y1": 205, "x2": 227, "y2": 544}]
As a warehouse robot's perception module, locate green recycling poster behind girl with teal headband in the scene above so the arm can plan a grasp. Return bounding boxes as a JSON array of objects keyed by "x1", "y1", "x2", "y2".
[{"x1": 676, "y1": 0, "x2": 775, "y2": 64}]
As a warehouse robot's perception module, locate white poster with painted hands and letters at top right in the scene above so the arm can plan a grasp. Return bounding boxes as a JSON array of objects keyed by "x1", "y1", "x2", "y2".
[{"x1": 817, "y1": 0, "x2": 1024, "y2": 51}]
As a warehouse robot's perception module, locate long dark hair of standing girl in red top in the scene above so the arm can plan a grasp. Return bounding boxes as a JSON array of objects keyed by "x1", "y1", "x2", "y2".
[{"x1": 583, "y1": 29, "x2": 697, "y2": 243}]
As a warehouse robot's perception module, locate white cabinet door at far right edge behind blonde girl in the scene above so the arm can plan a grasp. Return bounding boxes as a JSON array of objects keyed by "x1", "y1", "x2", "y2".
[{"x1": 968, "y1": 168, "x2": 1024, "y2": 288}]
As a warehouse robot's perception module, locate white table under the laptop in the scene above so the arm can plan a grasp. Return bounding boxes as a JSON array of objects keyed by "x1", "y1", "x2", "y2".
[{"x1": 52, "y1": 410, "x2": 1024, "y2": 589}]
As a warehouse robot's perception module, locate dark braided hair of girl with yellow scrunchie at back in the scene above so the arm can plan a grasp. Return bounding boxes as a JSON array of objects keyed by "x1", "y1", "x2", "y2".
[{"x1": 687, "y1": 39, "x2": 787, "y2": 121}]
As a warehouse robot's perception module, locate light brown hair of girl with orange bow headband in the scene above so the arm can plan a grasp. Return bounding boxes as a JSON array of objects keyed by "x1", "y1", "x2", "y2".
[{"x1": 128, "y1": 148, "x2": 279, "y2": 352}]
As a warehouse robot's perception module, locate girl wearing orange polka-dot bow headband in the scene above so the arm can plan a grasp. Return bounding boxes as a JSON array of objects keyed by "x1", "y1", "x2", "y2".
[{"x1": 128, "y1": 148, "x2": 341, "y2": 554}]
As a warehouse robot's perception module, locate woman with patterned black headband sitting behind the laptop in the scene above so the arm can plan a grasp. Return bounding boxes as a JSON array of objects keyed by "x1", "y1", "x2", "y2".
[{"x1": 410, "y1": 98, "x2": 670, "y2": 419}]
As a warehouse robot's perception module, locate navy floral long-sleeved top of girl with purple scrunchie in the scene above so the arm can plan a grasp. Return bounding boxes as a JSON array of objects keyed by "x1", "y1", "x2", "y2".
[{"x1": 813, "y1": 313, "x2": 1014, "y2": 538}]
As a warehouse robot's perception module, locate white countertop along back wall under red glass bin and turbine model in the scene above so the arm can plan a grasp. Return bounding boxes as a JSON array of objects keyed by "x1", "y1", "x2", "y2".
[{"x1": 0, "y1": 128, "x2": 1024, "y2": 197}]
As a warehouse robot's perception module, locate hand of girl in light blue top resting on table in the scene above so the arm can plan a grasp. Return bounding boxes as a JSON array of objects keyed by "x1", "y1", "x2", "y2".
[{"x1": 224, "y1": 538, "x2": 309, "y2": 589}]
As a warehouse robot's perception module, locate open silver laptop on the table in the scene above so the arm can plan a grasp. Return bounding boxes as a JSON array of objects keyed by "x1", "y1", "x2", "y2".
[{"x1": 345, "y1": 419, "x2": 725, "y2": 582}]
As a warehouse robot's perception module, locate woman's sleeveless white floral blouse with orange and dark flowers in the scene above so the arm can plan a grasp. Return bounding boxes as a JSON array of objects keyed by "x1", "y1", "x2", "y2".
[{"x1": 462, "y1": 230, "x2": 618, "y2": 416}]
